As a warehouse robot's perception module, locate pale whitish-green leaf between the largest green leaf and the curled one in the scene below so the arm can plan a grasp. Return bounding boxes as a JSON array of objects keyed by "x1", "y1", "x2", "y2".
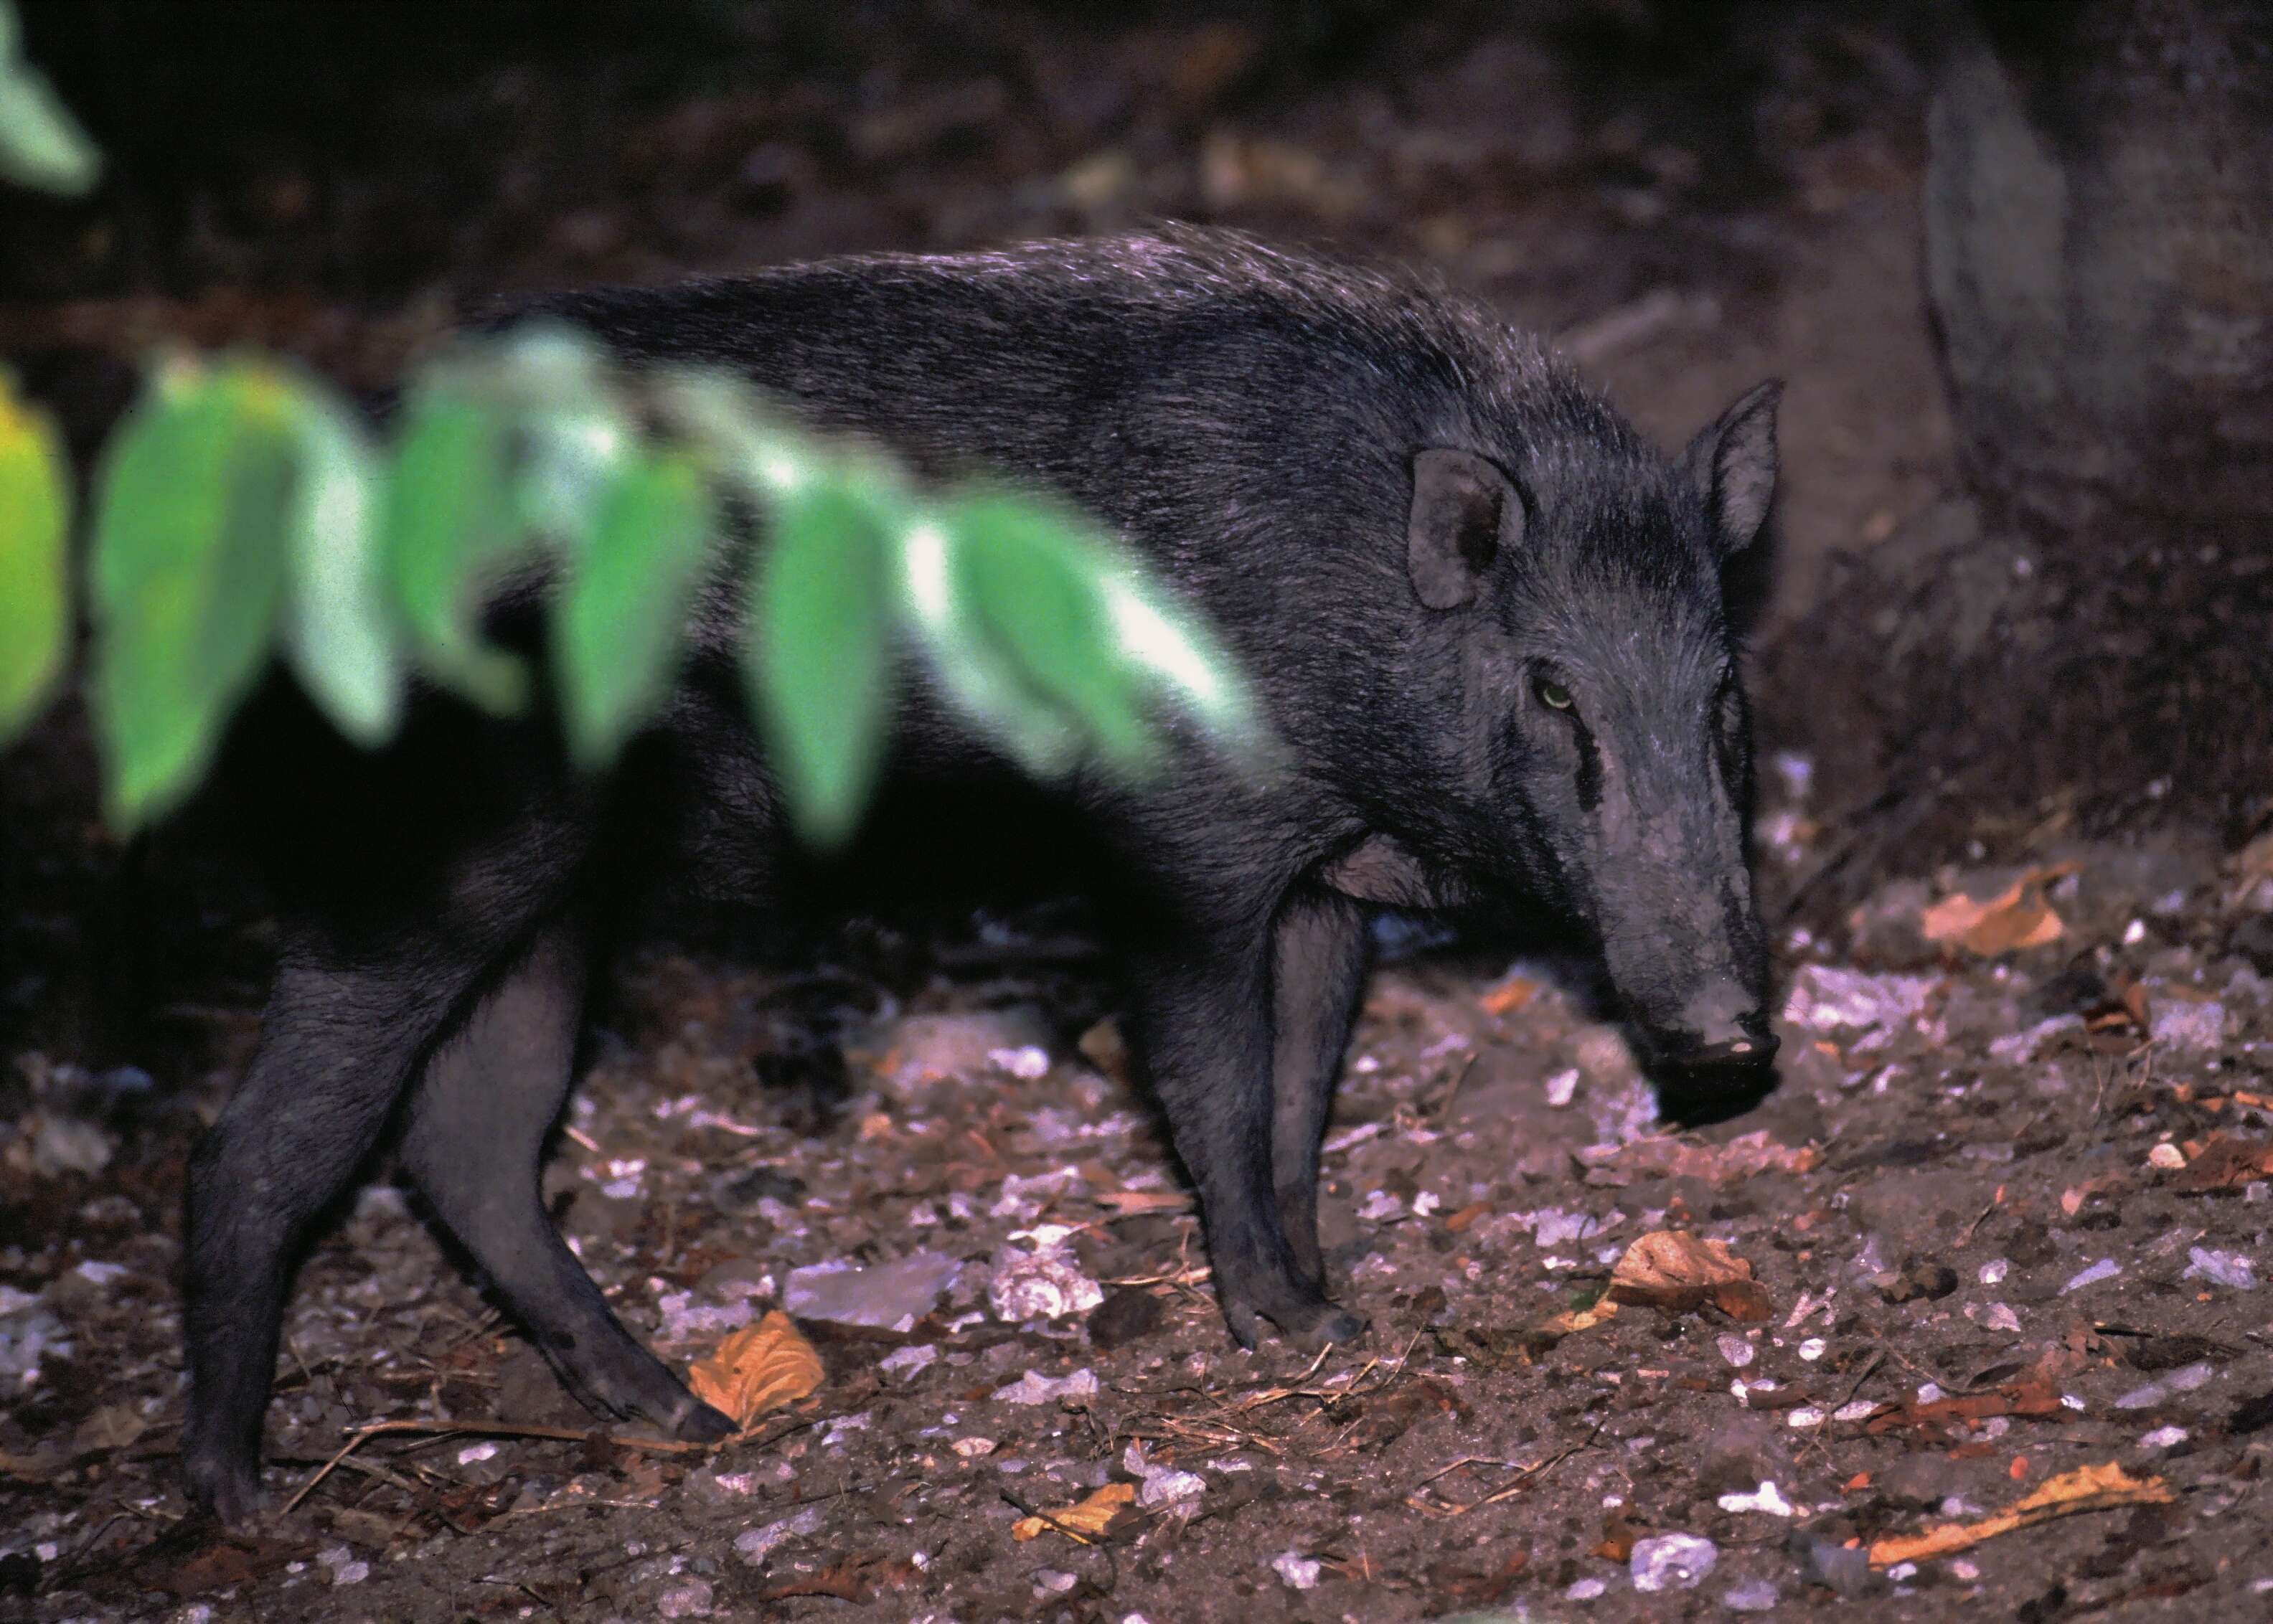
[{"x1": 284, "y1": 384, "x2": 403, "y2": 750}]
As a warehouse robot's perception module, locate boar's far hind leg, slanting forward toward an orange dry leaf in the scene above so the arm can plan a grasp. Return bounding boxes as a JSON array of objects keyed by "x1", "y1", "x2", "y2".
[{"x1": 403, "y1": 929, "x2": 734, "y2": 1440}]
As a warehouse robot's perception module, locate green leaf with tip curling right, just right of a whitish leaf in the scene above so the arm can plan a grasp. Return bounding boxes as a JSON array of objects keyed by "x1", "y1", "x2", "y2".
[{"x1": 380, "y1": 382, "x2": 530, "y2": 713}]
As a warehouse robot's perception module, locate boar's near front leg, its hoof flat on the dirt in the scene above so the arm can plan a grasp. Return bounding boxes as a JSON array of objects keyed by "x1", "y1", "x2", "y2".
[{"x1": 1132, "y1": 906, "x2": 1366, "y2": 1347}]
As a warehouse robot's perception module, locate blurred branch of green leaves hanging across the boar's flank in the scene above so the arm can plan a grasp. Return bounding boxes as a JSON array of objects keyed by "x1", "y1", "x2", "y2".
[{"x1": 0, "y1": 325, "x2": 1259, "y2": 843}]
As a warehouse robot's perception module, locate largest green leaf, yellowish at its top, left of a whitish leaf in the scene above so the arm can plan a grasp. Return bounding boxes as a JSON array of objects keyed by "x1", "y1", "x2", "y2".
[{"x1": 91, "y1": 361, "x2": 296, "y2": 827}]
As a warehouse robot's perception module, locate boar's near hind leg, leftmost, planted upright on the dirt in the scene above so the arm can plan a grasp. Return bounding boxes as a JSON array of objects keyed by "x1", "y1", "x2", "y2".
[{"x1": 182, "y1": 952, "x2": 507, "y2": 1524}]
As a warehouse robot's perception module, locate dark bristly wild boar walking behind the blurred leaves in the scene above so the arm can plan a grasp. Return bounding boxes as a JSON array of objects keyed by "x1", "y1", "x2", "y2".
[{"x1": 184, "y1": 230, "x2": 1773, "y2": 1517}]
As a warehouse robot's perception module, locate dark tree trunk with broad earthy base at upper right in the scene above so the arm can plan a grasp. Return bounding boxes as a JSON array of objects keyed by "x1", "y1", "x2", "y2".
[{"x1": 1766, "y1": 0, "x2": 2273, "y2": 863}]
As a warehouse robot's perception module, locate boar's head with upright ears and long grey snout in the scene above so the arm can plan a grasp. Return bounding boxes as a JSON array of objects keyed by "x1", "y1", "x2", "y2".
[{"x1": 1407, "y1": 384, "x2": 1780, "y2": 1065}]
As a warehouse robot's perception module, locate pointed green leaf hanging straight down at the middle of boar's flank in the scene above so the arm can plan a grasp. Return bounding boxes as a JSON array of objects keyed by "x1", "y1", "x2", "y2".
[{"x1": 763, "y1": 470, "x2": 893, "y2": 845}]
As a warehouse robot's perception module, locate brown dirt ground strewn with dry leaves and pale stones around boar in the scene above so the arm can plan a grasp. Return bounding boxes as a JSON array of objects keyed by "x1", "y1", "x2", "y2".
[{"x1": 0, "y1": 4, "x2": 2273, "y2": 1624}]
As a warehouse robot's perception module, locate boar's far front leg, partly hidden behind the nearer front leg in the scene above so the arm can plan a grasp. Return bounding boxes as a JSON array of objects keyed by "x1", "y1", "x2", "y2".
[{"x1": 1271, "y1": 890, "x2": 1373, "y2": 1290}]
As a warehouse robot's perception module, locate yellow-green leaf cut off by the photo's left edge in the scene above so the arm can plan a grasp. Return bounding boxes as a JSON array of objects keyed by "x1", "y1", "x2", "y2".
[{"x1": 0, "y1": 372, "x2": 70, "y2": 742}]
